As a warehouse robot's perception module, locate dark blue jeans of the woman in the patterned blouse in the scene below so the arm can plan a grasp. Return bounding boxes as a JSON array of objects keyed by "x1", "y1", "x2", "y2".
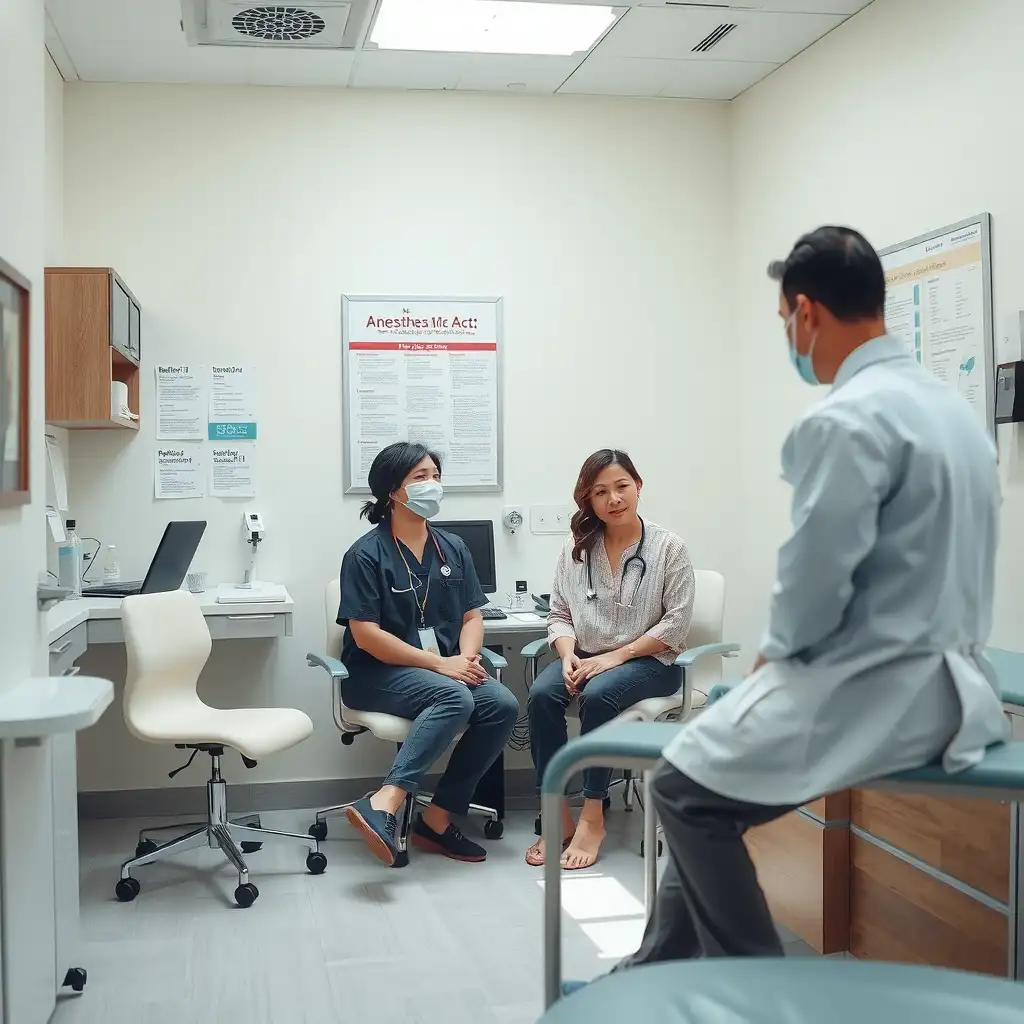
[{"x1": 529, "y1": 654, "x2": 683, "y2": 800}]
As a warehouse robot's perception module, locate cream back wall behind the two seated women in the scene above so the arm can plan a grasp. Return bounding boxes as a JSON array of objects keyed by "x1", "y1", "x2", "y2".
[{"x1": 65, "y1": 85, "x2": 738, "y2": 791}]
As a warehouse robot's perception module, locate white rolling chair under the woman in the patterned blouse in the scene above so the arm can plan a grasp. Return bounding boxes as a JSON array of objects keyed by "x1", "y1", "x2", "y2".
[{"x1": 522, "y1": 569, "x2": 739, "y2": 854}]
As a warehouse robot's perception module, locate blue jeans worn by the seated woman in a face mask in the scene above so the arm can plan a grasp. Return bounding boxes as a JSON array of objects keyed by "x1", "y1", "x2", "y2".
[{"x1": 341, "y1": 665, "x2": 519, "y2": 814}]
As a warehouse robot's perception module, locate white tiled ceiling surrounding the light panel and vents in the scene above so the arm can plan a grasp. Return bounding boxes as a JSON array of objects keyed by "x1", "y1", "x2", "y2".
[{"x1": 41, "y1": 0, "x2": 871, "y2": 99}]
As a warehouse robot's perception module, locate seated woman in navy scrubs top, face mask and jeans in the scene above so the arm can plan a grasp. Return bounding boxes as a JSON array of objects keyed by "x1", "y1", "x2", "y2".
[{"x1": 338, "y1": 441, "x2": 519, "y2": 866}]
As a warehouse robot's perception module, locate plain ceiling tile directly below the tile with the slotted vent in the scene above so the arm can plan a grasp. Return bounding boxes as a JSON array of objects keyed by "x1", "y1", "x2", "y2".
[{"x1": 559, "y1": 55, "x2": 778, "y2": 99}]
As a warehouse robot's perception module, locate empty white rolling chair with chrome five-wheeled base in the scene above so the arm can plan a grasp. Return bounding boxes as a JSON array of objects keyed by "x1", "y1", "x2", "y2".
[{"x1": 115, "y1": 590, "x2": 327, "y2": 907}]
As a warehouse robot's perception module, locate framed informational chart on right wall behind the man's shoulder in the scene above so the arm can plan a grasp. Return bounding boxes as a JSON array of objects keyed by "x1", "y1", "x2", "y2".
[{"x1": 880, "y1": 213, "x2": 995, "y2": 431}]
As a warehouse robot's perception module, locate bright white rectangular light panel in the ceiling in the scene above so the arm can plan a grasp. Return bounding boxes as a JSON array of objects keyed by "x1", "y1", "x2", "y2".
[{"x1": 370, "y1": 0, "x2": 617, "y2": 56}]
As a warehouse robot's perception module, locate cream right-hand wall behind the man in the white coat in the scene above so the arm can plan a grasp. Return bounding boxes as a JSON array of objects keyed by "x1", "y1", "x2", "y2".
[{"x1": 729, "y1": 0, "x2": 1024, "y2": 651}]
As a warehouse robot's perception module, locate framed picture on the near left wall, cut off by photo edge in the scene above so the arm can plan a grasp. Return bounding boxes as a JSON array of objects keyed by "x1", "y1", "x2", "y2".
[{"x1": 0, "y1": 259, "x2": 31, "y2": 507}]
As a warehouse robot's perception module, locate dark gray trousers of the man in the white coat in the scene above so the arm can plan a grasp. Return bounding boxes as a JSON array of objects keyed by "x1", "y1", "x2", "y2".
[{"x1": 615, "y1": 761, "x2": 794, "y2": 970}]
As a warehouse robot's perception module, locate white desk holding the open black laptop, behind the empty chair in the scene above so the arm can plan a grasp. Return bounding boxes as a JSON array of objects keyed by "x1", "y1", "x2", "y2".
[{"x1": 46, "y1": 591, "x2": 295, "y2": 675}]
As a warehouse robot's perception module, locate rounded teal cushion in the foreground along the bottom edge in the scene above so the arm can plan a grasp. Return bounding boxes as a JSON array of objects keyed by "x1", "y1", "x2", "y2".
[{"x1": 541, "y1": 957, "x2": 1024, "y2": 1024}]
